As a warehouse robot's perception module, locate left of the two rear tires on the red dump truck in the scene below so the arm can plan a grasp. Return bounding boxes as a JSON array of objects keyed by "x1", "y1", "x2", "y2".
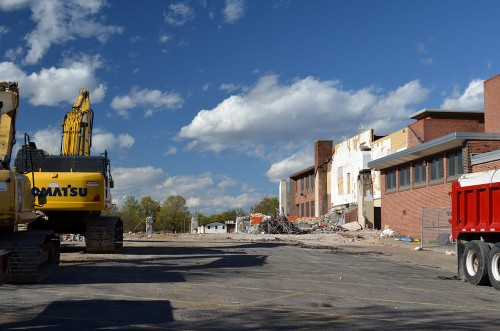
[{"x1": 463, "y1": 240, "x2": 490, "y2": 285}]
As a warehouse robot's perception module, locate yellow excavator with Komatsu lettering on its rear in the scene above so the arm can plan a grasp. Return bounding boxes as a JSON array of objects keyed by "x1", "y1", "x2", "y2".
[{"x1": 15, "y1": 89, "x2": 123, "y2": 253}]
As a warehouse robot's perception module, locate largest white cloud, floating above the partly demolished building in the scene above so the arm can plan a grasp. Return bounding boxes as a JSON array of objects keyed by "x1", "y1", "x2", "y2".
[{"x1": 178, "y1": 75, "x2": 429, "y2": 157}]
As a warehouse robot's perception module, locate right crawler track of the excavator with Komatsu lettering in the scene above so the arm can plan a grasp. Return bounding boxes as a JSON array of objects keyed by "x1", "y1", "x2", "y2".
[{"x1": 85, "y1": 217, "x2": 123, "y2": 254}]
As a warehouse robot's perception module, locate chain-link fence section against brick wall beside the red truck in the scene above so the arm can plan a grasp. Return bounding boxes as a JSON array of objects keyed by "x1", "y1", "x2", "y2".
[{"x1": 420, "y1": 207, "x2": 455, "y2": 250}]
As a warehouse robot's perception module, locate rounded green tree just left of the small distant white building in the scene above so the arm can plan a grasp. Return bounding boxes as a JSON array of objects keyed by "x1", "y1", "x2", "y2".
[{"x1": 158, "y1": 195, "x2": 191, "y2": 233}]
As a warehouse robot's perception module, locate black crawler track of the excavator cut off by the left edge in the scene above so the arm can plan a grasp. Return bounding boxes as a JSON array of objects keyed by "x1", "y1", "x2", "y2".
[{"x1": 0, "y1": 231, "x2": 60, "y2": 284}]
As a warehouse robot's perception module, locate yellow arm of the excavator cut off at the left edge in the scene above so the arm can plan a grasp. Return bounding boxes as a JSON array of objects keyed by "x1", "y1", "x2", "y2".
[{"x1": 0, "y1": 82, "x2": 19, "y2": 170}]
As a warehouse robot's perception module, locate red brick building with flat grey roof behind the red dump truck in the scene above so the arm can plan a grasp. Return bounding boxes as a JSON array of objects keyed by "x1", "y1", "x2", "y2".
[{"x1": 368, "y1": 75, "x2": 500, "y2": 237}]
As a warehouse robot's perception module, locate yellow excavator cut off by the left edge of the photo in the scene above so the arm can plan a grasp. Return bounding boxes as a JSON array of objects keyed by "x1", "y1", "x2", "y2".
[{"x1": 0, "y1": 82, "x2": 60, "y2": 284}]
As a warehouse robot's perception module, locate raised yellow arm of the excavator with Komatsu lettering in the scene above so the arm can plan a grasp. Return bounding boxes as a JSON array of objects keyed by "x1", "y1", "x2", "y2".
[{"x1": 61, "y1": 89, "x2": 94, "y2": 156}]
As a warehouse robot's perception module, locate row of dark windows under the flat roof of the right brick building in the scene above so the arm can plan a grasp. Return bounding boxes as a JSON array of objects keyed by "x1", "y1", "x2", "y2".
[{"x1": 385, "y1": 151, "x2": 463, "y2": 192}]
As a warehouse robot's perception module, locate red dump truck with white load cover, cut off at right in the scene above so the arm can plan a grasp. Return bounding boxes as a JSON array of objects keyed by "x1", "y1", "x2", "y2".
[{"x1": 451, "y1": 169, "x2": 500, "y2": 290}]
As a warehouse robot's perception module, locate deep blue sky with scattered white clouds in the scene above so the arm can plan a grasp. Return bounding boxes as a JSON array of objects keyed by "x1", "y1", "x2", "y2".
[{"x1": 0, "y1": 0, "x2": 500, "y2": 215}]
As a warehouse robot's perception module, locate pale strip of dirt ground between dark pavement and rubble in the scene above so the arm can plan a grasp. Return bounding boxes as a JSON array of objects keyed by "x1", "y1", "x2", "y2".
[{"x1": 124, "y1": 230, "x2": 457, "y2": 274}]
